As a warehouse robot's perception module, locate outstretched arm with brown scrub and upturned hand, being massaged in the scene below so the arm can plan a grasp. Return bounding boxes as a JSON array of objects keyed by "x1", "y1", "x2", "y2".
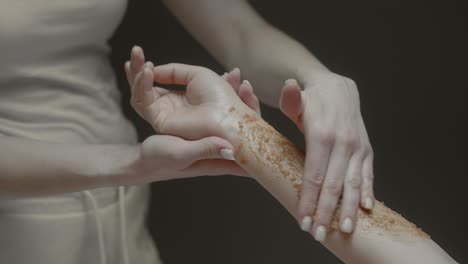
[{"x1": 130, "y1": 58, "x2": 456, "y2": 264}]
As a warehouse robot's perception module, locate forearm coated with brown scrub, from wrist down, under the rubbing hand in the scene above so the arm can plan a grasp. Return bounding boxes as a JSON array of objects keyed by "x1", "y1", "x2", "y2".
[{"x1": 223, "y1": 106, "x2": 456, "y2": 264}]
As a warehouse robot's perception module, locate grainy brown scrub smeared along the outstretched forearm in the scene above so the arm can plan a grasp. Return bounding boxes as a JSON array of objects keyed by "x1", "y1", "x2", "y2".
[{"x1": 238, "y1": 114, "x2": 429, "y2": 238}]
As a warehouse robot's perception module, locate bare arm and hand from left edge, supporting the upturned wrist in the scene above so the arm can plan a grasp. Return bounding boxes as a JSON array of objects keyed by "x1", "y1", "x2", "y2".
[{"x1": 0, "y1": 67, "x2": 260, "y2": 197}]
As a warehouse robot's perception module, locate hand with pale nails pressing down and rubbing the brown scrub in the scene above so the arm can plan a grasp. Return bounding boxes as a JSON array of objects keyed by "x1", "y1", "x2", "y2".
[{"x1": 280, "y1": 73, "x2": 374, "y2": 240}]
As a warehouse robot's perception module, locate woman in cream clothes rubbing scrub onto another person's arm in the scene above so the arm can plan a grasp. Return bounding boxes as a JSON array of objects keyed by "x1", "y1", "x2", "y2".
[{"x1": 0, "y1": 0, "x2": 373, "y2": 263}]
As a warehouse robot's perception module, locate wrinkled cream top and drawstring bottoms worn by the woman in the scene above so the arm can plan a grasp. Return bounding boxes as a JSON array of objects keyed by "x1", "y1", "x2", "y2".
[{"x1": 0, "y1": 0, "x2": 159, "y2": 264}]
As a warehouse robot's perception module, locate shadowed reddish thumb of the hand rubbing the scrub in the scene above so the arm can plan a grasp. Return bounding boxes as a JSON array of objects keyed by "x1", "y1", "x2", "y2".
[{"x1": 280, "y1": 79, "x2": 304, "y2": 132}]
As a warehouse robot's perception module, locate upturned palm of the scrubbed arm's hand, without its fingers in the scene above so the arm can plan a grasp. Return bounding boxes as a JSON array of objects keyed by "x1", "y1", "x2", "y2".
[{"x1": 144, "y1": 69, "x2": 232, "y2": 139}]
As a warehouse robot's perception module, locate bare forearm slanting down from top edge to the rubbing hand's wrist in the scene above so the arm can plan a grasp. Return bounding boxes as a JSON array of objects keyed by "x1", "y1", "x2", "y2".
[{"x1": 163, "y1": 0, "x2": 322, "y2": 106}]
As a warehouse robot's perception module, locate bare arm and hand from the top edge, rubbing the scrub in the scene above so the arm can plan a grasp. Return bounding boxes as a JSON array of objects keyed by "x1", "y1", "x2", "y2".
[{"x1": 161, "y1": 0, "x2": 374, "y2": 239}]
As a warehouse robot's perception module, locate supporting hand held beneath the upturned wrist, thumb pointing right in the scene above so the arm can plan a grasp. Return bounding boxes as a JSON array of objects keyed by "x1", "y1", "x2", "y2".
[{"x1": 126, "y1": 135, "x2": 247, "y2": 184}]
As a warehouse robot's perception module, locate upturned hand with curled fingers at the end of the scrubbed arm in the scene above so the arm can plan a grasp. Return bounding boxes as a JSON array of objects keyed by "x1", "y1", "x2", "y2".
[{"x1": 125, "y1": 47, "x2": 260, "y2": 139}]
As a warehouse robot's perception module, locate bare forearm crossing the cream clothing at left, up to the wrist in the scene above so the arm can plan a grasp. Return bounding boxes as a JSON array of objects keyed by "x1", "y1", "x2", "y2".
[{"x1": 0, "y1": 136, "x2": 139, "y2": 196}]
